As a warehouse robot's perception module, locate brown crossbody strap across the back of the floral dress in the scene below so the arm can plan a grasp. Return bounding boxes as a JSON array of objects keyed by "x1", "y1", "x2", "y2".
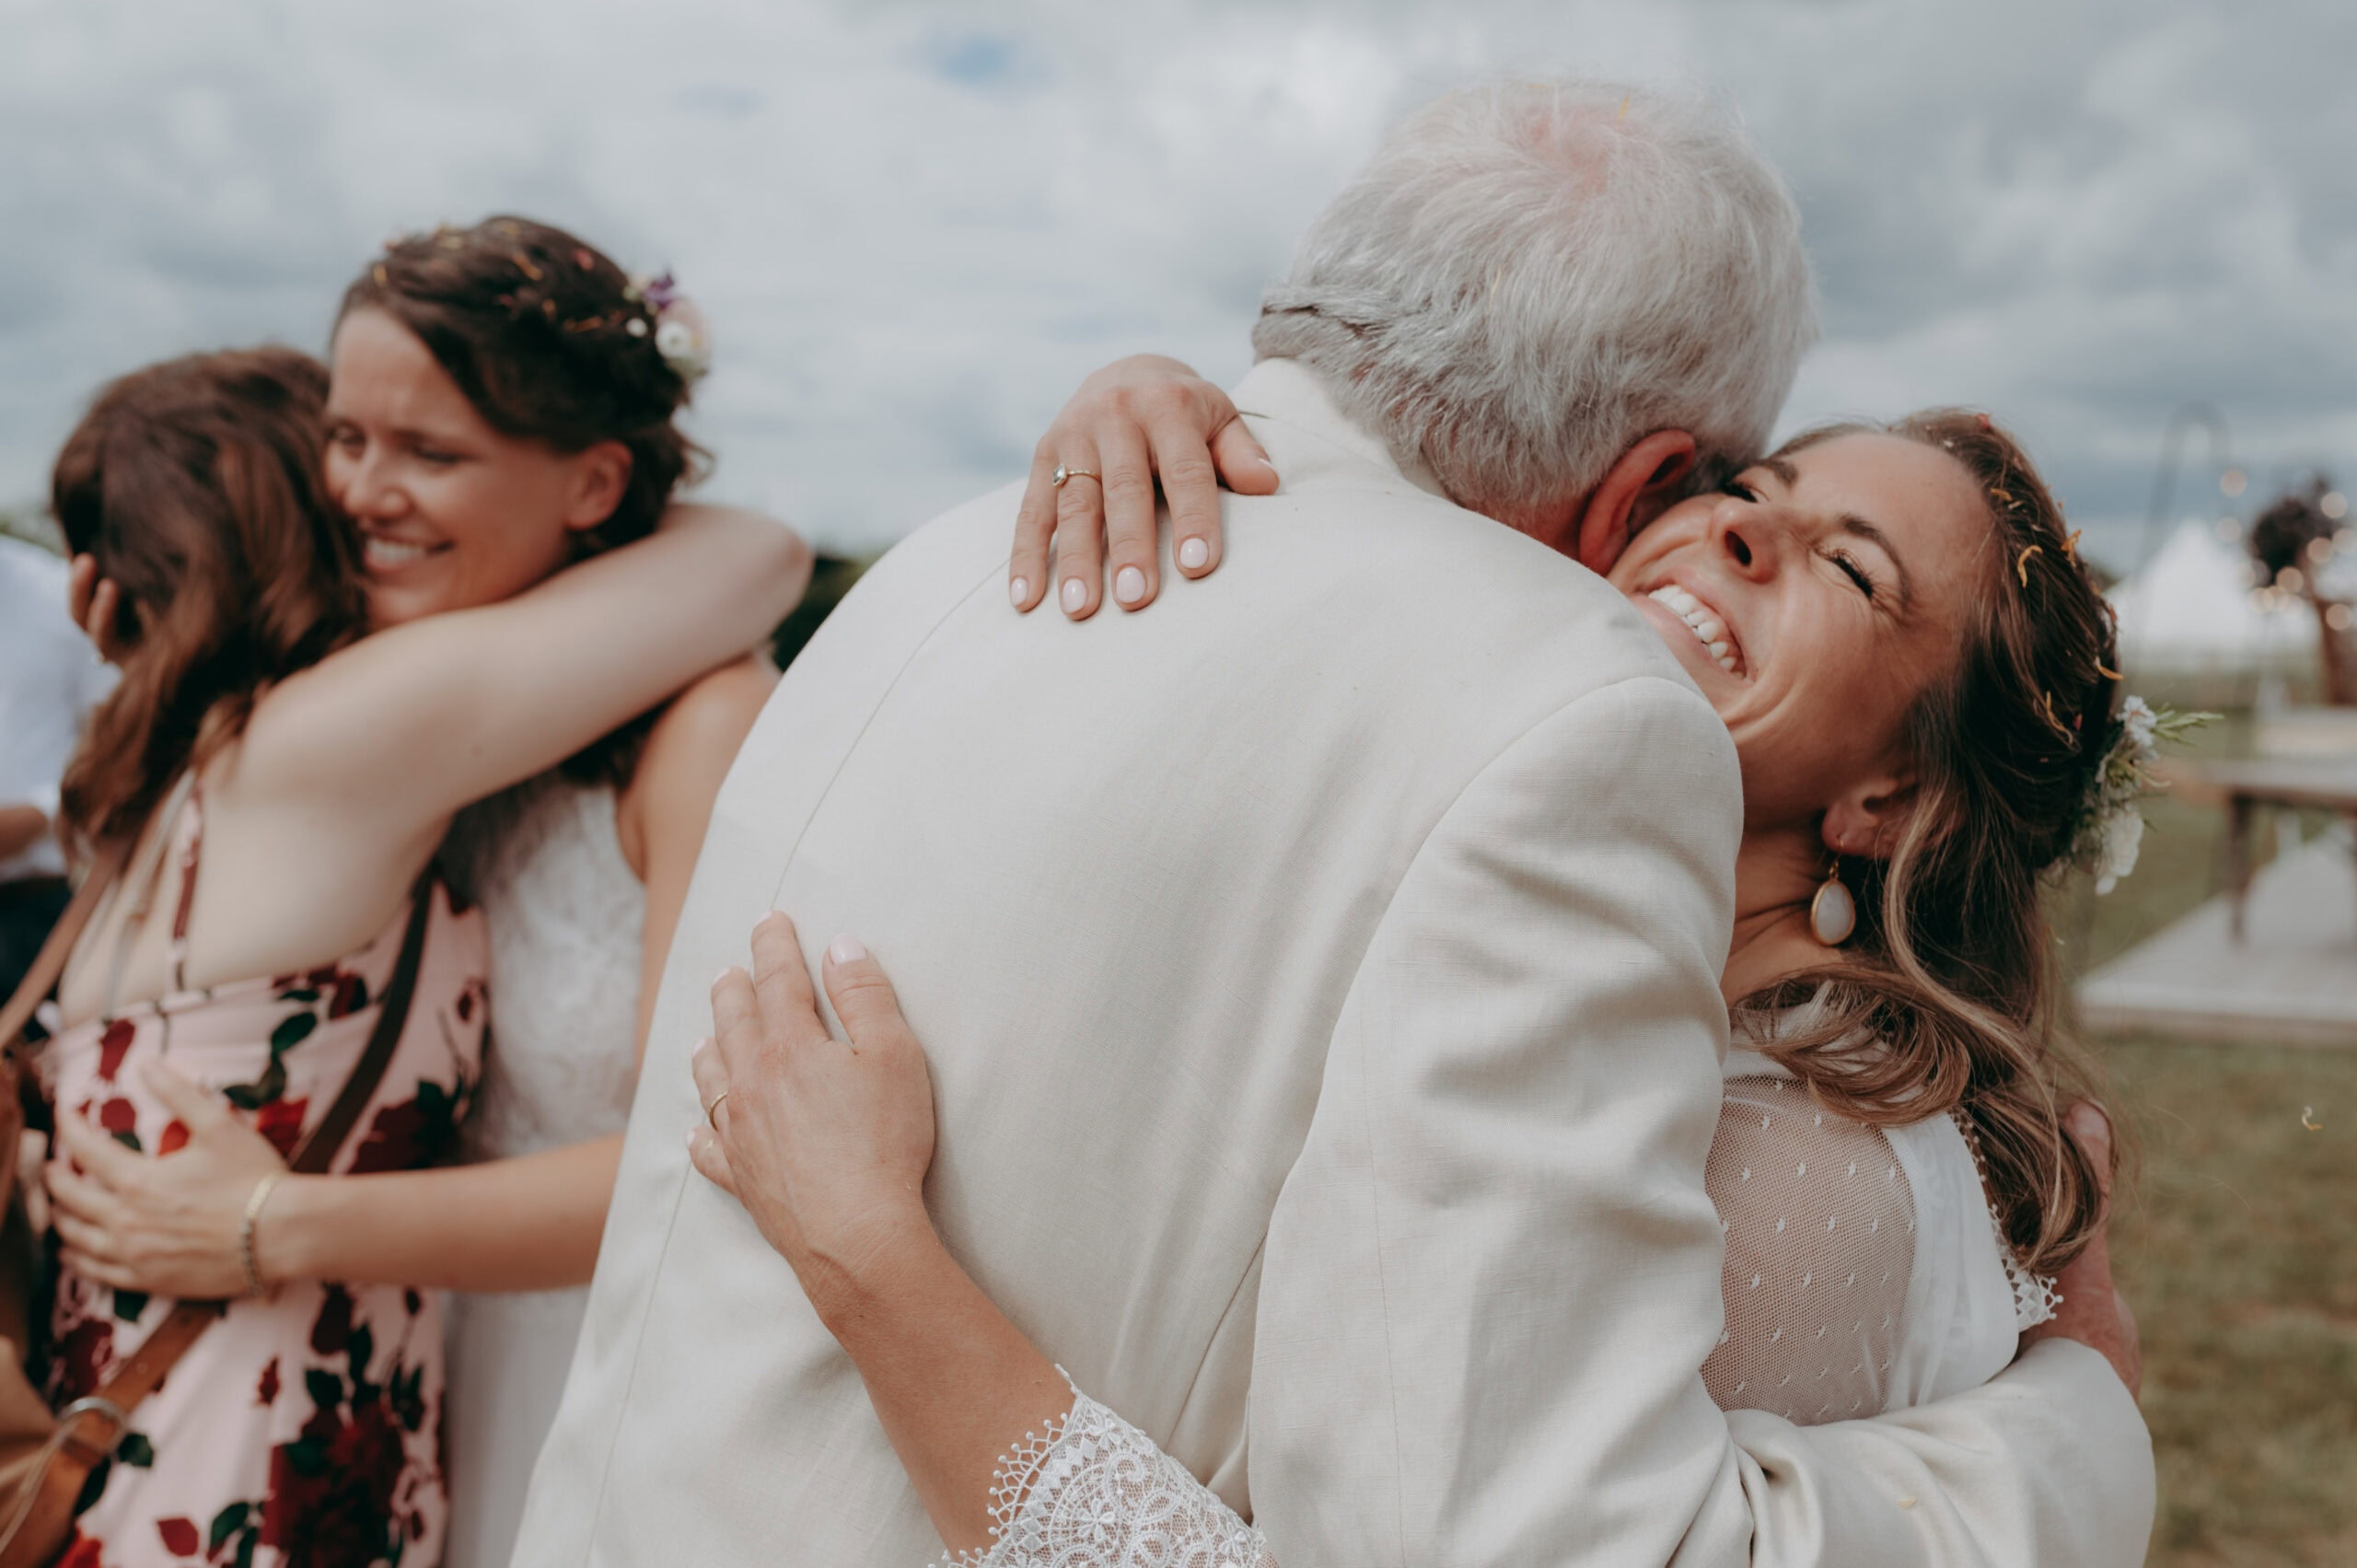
[{"x1": 0, "y1": 870, "x2": 434, "y2": 1563}]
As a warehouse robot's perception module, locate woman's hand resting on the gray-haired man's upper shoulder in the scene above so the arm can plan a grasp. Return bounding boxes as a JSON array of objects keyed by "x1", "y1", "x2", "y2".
[{"x1": 1006, "y1": 354, "x2": 1278, "y2": 621}]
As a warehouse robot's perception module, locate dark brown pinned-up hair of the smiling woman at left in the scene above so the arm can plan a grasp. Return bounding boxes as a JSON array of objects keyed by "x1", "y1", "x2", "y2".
[{"x1": 337, "y1": 215, "x2": 710, "y2": 785}]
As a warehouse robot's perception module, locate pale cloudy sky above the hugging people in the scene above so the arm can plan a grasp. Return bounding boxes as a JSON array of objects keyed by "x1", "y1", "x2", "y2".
[{"x1": 0, "y1": 0, "x2": 2357, "y2": 563}]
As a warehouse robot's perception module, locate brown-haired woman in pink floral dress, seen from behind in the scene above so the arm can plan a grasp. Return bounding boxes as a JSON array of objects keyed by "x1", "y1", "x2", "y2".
[{"x1": 41, "y1": 352, "x2": 804, "y2": 1568}]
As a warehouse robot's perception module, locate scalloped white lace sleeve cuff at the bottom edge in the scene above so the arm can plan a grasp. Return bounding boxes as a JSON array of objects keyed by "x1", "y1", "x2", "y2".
[{"x1": 935, "y1": 1388, "x2": 1278, "y2": 1568}]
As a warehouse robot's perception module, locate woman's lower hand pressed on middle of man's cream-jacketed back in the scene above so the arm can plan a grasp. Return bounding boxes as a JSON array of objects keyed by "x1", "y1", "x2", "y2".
[{"x1": 689, "y1": 915, "x2": 934, "y2": 1323}]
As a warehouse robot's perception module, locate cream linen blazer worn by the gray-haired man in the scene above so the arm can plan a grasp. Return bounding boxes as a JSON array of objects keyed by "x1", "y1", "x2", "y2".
[{"x1": 517, "y1": 361, "x2": 2152, "y2": 1568}]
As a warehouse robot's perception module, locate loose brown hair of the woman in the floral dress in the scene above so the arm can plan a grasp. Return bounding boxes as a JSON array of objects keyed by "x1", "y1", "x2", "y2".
[{"x1": 50, "y1": 349, "x2": 363, "y2": 846}]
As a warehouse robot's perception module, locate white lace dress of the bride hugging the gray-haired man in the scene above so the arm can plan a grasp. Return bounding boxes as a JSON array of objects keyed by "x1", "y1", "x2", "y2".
[{"x1": 928, "y1": 1028, "x2": 2058, "y2": 1568}]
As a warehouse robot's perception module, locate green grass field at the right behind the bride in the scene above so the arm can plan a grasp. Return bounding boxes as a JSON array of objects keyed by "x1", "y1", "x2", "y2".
[{"x1": 2058, "y1": 733, "x2": 2357, "y2": 1568}]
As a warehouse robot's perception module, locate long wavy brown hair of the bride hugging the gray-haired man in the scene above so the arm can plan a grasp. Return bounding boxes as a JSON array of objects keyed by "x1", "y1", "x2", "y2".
[{"x1": 1737, "y1": 408, "x2": 2119, "y2": 1273}]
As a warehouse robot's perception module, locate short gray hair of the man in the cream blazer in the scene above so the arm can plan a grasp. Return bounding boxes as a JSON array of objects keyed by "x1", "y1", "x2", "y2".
[{"x1": 1251, "y1": 80, "x2": 1817, "y2": 526}]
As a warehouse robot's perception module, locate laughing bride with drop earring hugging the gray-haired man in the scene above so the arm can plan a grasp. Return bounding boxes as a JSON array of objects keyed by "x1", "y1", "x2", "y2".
[{"x1": 691, "y1": 399, "x2": 2152, "y2": 1568}]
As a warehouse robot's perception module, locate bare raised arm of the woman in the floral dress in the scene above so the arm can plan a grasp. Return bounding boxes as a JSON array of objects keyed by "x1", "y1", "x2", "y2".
[{"x1": 240, "y1": 507, "x2": 811, "y2": 837}]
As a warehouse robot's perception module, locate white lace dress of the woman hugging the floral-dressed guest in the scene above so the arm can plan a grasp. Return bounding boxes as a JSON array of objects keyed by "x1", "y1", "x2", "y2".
[{"x1": 443, "y1": 781, "x2": 645, "y2": 1568}]
